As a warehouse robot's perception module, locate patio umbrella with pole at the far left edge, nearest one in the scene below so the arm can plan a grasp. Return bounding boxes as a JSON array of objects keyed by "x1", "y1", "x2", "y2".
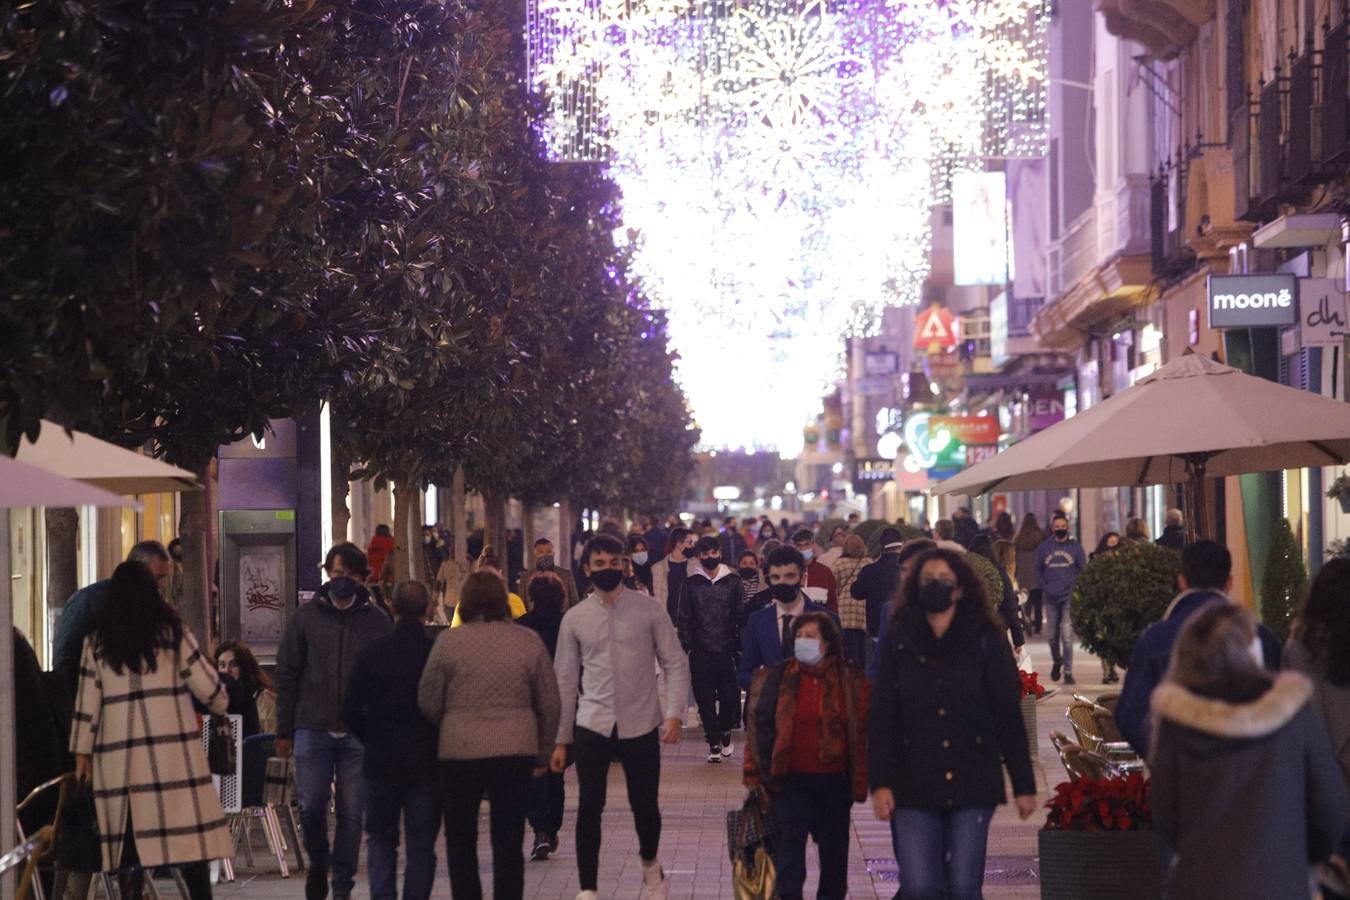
[{"x1": 0, "y1": 455, "x2": 140, "y2": 896}]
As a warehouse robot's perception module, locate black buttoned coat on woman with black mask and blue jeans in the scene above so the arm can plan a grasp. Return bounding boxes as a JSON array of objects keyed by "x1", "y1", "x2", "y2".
[{"x1": 867, "y1": 607, "x2": 1035, "y2": 810}]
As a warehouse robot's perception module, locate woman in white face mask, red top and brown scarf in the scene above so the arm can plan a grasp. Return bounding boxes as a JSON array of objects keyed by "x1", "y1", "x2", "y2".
[{"x1": 744, "y1": 613, "x2": 869, "y2": 900}]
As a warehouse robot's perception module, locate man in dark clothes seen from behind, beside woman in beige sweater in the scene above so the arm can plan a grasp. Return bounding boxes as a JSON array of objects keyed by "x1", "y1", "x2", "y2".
[{"x1": 342, "y1": 582, "x2": 440, "y2": 900}]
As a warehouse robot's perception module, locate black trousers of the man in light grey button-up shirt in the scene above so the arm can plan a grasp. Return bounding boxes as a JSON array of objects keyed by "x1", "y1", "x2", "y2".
[{"x1": 574, "y1": 726, "x2": 662, "y2": 891}]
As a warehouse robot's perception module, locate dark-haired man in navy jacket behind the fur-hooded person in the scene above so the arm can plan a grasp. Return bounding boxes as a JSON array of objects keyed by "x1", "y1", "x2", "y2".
[{"x1": 1115, "y1": 541, "x2": 1281, "y2": 758}]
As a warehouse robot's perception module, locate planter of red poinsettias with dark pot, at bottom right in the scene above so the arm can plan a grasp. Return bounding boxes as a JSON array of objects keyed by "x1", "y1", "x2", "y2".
[{"x1": 1040, "y1": 773, "x2": 1166, "y2": 900}]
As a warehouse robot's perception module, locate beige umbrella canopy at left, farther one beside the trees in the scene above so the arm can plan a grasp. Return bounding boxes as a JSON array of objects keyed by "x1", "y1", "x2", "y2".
[{"x1": 15, "y1": 420, "x2": 197, "y2": 496}]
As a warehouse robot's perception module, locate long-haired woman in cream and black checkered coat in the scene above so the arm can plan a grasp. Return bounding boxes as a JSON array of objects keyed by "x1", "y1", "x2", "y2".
[{"x1": 70, "y1": 563, "x2": 234, "y2": 900}]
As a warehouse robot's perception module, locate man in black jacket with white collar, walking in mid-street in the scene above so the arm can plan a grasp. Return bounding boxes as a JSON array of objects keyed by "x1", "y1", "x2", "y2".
[{"x1": 675, "y1": 537, "x2": 745, "y2": 762}]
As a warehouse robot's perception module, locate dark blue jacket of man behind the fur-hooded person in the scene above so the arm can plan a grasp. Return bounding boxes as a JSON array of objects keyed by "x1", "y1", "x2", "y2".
[{"x1": 1115, "y1": 590, "x2": 1281, "y2": 757}]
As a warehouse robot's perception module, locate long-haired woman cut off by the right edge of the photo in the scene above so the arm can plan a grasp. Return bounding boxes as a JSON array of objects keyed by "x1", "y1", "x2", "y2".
[{"x1": 1284, "y1": 557, "x2": 1350, "y2": 900}]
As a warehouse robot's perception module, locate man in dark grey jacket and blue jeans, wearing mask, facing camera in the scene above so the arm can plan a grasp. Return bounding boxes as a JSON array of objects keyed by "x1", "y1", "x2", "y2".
[{"x1": 275, "y1": 544, "x2": 393, "y2": 900}]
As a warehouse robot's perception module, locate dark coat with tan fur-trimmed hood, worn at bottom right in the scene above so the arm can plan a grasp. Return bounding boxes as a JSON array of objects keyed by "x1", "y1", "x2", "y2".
[{"x1": 1149, "y1": 672, "x2": 1346, "y2": 900}]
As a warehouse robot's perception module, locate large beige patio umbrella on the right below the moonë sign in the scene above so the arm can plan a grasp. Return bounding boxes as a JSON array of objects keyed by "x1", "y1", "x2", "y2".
[{"x1": 936, "y1": 354, "x2": 1350, "y2": 534}]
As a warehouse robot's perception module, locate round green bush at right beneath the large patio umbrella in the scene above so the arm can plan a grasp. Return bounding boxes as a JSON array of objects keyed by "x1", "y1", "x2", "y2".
[{"x1": 1071, "y1": 544, "x2": 1181, "y2": 674}]
